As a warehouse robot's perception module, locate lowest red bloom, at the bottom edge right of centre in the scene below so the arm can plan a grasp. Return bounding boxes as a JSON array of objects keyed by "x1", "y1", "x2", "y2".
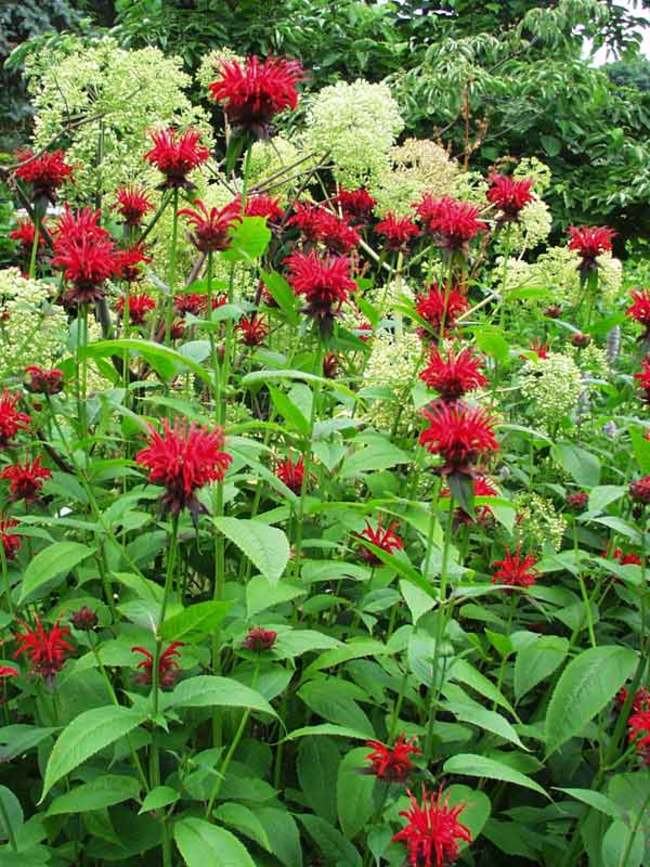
[{"x1": 393, "y1": 787, "x2": 472, "y2": 867}]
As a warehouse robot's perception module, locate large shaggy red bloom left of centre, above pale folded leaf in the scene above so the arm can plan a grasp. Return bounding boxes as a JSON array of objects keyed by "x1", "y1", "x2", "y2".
[{"x1": 135, "y1": 419, "x2": 232, "y2": 515}]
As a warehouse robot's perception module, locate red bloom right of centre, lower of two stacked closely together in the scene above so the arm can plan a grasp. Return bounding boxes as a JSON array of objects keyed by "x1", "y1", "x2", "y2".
[{"x1": 420, "y1": 402, "x2": 499, "y2": 475}]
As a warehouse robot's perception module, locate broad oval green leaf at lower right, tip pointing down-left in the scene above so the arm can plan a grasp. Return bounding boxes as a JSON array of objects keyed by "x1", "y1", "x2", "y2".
[{"x1": 546, "y1": 645, "x2": 637, "y2": 754}]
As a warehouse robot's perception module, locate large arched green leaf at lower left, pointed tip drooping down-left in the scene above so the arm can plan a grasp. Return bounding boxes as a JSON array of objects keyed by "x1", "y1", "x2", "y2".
[{"x1": 39, "y1": 708, "x2": 147, "y2": 803}]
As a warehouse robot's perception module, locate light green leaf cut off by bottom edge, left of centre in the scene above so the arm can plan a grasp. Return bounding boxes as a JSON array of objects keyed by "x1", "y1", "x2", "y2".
[{"x1": 174, "y1": 817, "x2": 255, "y2": 867}]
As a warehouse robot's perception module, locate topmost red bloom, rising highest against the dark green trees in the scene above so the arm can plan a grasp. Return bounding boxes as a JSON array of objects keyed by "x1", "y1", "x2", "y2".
[{"x1": 210, "y1": 56, "x2": 304, "y2": 137}]
